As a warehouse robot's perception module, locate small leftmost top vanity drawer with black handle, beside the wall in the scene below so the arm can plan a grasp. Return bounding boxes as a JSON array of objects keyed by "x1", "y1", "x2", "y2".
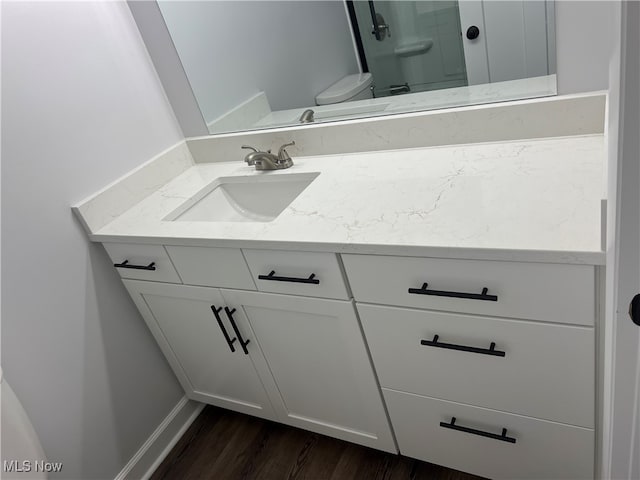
[{"x1": 103, "y1": 243, "x2": 182, "y2": 283}]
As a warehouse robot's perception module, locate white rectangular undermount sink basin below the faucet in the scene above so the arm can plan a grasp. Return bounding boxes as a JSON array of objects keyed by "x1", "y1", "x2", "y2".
[{"x1": 164, "y1": 172, "x2": 320, "y2": 222}]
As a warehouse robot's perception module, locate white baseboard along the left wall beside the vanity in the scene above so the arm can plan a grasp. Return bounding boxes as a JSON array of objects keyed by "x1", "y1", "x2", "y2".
[{"x1": 114, "y1": 396, "x2": 205, "y2": 480}]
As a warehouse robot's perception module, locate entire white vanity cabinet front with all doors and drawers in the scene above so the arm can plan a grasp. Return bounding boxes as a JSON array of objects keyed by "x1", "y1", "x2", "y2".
[{"x1": 108, "y1": 245, "x2": 597, "y2": 480}]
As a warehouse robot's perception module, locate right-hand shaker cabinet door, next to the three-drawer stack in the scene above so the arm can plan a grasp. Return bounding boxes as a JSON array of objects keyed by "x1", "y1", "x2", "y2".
[{"x1": 222, "y1": 290, "x2": 396, "y2": 452}]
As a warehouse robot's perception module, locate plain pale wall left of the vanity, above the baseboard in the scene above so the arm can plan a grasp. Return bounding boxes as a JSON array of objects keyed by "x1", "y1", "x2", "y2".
[{"x1": 1, "y1": 1, "x2": 183, "y2": 479}]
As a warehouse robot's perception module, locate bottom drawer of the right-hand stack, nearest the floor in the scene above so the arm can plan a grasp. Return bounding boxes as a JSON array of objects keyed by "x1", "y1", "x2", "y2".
[{"x1": 382, "y1": 389, "x2": 594, "y2": 480}]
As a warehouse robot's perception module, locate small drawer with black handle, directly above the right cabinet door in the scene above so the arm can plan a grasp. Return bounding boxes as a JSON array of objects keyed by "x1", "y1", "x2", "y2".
[{"x1": 243, "y1": 249, "x2": 350, "y2": 300}]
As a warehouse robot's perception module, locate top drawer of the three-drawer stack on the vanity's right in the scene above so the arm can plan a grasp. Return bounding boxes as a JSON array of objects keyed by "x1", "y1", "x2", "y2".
[{"x1": 342, "y1": 255, "x2": 595, "y2": 325}]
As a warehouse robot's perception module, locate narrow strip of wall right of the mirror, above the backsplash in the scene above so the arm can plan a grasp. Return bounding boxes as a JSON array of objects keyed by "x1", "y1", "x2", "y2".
[{"x1": 556, "y1": 0, "x2": 620, "y2": 95}]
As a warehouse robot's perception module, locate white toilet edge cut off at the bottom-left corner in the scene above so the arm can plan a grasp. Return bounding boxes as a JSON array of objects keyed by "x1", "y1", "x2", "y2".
[{"x1": 0, "y1": 368, "x2": 47, "y2": 480}]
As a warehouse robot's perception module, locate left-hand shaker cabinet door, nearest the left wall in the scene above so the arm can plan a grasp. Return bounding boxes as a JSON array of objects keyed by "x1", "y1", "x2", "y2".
[{"x1": 124, "y1": 280, "x2": 274, "y2": 419}]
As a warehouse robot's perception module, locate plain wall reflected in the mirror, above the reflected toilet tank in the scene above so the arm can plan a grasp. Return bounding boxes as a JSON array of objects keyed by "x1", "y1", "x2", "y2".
[{"x1": 159, "y1": 0, "x2": 359, "y2": 123}]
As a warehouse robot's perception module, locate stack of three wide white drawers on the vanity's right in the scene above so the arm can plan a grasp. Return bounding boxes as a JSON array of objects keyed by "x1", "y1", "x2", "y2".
[{"x1": 342, "y1": 255, "x2": 596, "y2": 480}]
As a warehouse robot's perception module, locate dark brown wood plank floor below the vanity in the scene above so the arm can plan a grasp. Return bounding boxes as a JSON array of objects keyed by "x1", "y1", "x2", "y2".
[{"x1": 151, "y1": 406, "x2": 480, "y2": 480}]
